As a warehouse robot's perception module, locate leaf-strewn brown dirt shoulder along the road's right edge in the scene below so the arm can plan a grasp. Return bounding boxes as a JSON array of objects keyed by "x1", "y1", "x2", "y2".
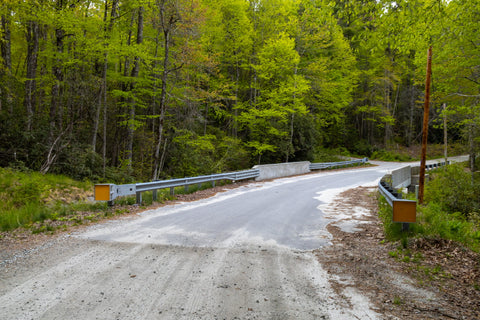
[{"x1": 316, "y1": 187, "x2": 480, "y2": 319}]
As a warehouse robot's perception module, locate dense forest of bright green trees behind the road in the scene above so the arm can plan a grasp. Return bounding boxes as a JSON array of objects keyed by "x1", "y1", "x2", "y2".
[{"x1": 0, "y1": 0, "x2": 480, "y2": 182}]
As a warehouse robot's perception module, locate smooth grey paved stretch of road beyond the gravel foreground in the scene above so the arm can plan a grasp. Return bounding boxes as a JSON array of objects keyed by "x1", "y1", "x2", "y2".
[{"x1": 82, "y1": 163, "x2": 404, "y2": 250}]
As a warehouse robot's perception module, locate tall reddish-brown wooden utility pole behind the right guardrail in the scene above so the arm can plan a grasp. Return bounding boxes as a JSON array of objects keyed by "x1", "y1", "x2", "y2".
[{"x1": 418, "y1": 46, "x2": 432, "y2": 204}]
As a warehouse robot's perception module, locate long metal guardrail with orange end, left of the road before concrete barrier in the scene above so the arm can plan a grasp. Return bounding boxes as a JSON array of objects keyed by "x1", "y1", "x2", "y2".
[{"x1": 95, "y1": 169, "x2": 260, "y2": 203}]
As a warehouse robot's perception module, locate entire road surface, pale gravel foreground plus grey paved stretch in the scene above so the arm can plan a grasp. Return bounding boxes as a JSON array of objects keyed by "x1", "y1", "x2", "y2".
[{"x1": 0, "y1": 159, "x2": 464, "y2": 320}]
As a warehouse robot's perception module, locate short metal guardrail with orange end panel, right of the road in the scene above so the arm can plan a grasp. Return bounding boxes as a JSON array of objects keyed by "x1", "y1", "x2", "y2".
[{"x1": 378, "y1": 180, "x2": 417, "y2": 225}]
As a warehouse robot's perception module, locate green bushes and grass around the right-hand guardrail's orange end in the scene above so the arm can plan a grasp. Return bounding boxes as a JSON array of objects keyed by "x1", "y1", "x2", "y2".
[{"x1": 380, "y1": 164, "x2": 480, "y2": 251}]
